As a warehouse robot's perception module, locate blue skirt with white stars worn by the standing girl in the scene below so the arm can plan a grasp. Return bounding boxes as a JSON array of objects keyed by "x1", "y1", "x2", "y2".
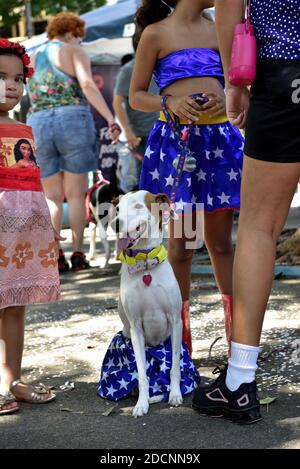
[{"x1": 140, "y1": 120, "x2": 244, "y2": 212}]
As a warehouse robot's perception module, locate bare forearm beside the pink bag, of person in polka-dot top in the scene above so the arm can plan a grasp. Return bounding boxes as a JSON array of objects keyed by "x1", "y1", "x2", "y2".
[{"x1": 215, "y1": 0, "x2": 244, "y2": 83}]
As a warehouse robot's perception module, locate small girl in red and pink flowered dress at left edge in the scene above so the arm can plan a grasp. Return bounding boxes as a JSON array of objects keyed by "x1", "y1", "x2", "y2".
[{"x1": 0, "y1": 39, "x2": 60, "y2": 415}]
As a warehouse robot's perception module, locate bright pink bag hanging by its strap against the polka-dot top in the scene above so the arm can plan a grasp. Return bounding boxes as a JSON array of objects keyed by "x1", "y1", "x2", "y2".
[{"x1": 229, "y1": 0, "x2": 257, "y2": 87}]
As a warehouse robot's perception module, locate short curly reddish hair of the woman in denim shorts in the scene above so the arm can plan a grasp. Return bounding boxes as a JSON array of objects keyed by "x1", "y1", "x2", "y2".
[{"x1": 47, "y1": 12, "x2": 85, "y2": 40}]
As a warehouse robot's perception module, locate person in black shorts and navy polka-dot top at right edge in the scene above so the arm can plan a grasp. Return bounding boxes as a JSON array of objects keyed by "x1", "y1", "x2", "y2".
[{"x1": 193, "y1": 0, "x2": 300, "y2": 423}]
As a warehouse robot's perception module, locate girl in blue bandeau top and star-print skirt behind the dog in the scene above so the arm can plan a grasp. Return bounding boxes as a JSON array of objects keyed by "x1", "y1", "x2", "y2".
[{"x1": 130, "y1": 0, "x2": 243, "y2": 351}]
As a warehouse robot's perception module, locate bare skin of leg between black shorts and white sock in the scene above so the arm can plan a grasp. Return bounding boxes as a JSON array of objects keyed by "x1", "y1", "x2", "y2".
[{"x1": 233, "y1": 157, "x2": 300, "y2": 346}]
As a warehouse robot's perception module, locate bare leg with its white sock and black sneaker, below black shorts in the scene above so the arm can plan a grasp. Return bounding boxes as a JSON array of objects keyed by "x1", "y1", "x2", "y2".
[{"x1": 193, "y1": 157, "x2": 300, "y2": 424}]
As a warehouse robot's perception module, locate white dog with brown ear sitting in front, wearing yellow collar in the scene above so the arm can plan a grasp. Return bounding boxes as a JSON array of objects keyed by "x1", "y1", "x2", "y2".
[{"x1": 112, "y1": 191, "x2": 182, "y2": 417}]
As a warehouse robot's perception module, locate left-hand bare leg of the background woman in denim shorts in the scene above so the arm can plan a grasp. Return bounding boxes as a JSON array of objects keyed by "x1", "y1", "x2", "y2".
[{"x1": 42, "y1": 173, "x2": 64, "y2": 233}]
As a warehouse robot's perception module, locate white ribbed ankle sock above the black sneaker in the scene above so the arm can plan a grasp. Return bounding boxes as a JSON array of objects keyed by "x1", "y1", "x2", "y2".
[{"x1": 226, "y1": 341, "x2": 260, "y2": 391}]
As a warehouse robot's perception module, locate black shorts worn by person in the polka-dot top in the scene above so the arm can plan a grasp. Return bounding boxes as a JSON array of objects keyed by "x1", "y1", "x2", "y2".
[{"x1": 244, "y1": 60, "x2": 300, "y2": 163}]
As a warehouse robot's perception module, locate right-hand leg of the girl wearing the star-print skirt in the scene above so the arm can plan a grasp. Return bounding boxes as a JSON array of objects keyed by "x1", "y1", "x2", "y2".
[{"x1": 204, "y1": 210, "x2": 234, "y2": 346}]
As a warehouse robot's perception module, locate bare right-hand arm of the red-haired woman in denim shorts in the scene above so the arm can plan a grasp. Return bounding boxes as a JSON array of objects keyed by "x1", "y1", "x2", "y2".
[{"x1": 73, "y1": 47, "x2": 114, "y2": 126}]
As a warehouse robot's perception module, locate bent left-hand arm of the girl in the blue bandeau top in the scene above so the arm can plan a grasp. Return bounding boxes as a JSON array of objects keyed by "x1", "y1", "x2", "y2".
[{"x1": 129, "y1": 25, "x2": 161, "y2": 112}]
